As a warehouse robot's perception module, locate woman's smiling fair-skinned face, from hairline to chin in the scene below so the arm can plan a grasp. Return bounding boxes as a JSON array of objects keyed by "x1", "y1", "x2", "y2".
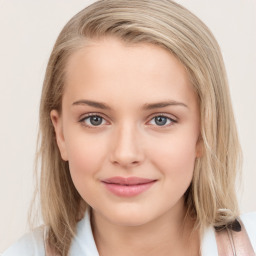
[{"x1": 51, "y1": 38, "x2": 200, "y2": 226}]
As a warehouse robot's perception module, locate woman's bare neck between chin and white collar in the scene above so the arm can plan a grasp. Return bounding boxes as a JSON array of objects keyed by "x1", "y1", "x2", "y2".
[{"x1": 92, "y1": 202, "x2": 199, "y2": 256}]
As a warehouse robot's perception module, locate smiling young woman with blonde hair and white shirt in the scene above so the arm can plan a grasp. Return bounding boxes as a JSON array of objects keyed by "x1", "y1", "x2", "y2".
[{"x1": 4, "y1": 0, "x2": 256, "y2": 256}]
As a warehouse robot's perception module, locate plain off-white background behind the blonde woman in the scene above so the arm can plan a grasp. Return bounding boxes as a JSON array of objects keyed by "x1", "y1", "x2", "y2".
[{"x1": 0, "y1": 0, "x2": 256, "y2": 252}]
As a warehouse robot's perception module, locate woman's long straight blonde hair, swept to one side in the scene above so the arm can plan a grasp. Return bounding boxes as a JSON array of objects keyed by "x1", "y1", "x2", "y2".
[{"x1": 30, "y1": 0, "x2": 241, "y2": 255}]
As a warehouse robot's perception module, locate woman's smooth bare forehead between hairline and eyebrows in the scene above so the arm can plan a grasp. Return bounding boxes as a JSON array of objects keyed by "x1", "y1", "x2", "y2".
[{"x1": 64, "y1": 38, "x2": 197, "y2": 106}]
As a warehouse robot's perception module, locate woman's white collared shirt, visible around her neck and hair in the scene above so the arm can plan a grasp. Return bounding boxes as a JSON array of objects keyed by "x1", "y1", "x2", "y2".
[{"x1": 2, "y1": 211, "x2": 256, "y2": 256}]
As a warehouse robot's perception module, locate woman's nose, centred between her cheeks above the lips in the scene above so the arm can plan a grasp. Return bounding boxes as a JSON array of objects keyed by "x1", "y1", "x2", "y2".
[{"x1": 110, "y1": 125, "x2": 144, "y2": 168}]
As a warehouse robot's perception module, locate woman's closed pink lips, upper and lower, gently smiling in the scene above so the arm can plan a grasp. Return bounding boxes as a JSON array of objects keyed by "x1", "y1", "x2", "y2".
[{"x1": 102, "y1": 177, "x2": 156, "y2": 197}]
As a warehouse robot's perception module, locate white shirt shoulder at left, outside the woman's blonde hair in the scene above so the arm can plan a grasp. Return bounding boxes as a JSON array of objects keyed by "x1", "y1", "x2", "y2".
[{"x1": 2, "y1": 227, "x2": 45, "y2": 256}]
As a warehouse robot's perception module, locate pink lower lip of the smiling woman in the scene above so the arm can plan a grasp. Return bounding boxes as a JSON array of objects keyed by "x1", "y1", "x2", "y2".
[{"x1": 103, "y1": 181, "x2": 155, "y2": 197}]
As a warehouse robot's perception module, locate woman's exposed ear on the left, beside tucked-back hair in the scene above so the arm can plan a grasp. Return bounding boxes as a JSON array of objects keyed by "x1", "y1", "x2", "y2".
[{"x1": 50, "y1": 109, "x2": 68, "y2": 161}]
